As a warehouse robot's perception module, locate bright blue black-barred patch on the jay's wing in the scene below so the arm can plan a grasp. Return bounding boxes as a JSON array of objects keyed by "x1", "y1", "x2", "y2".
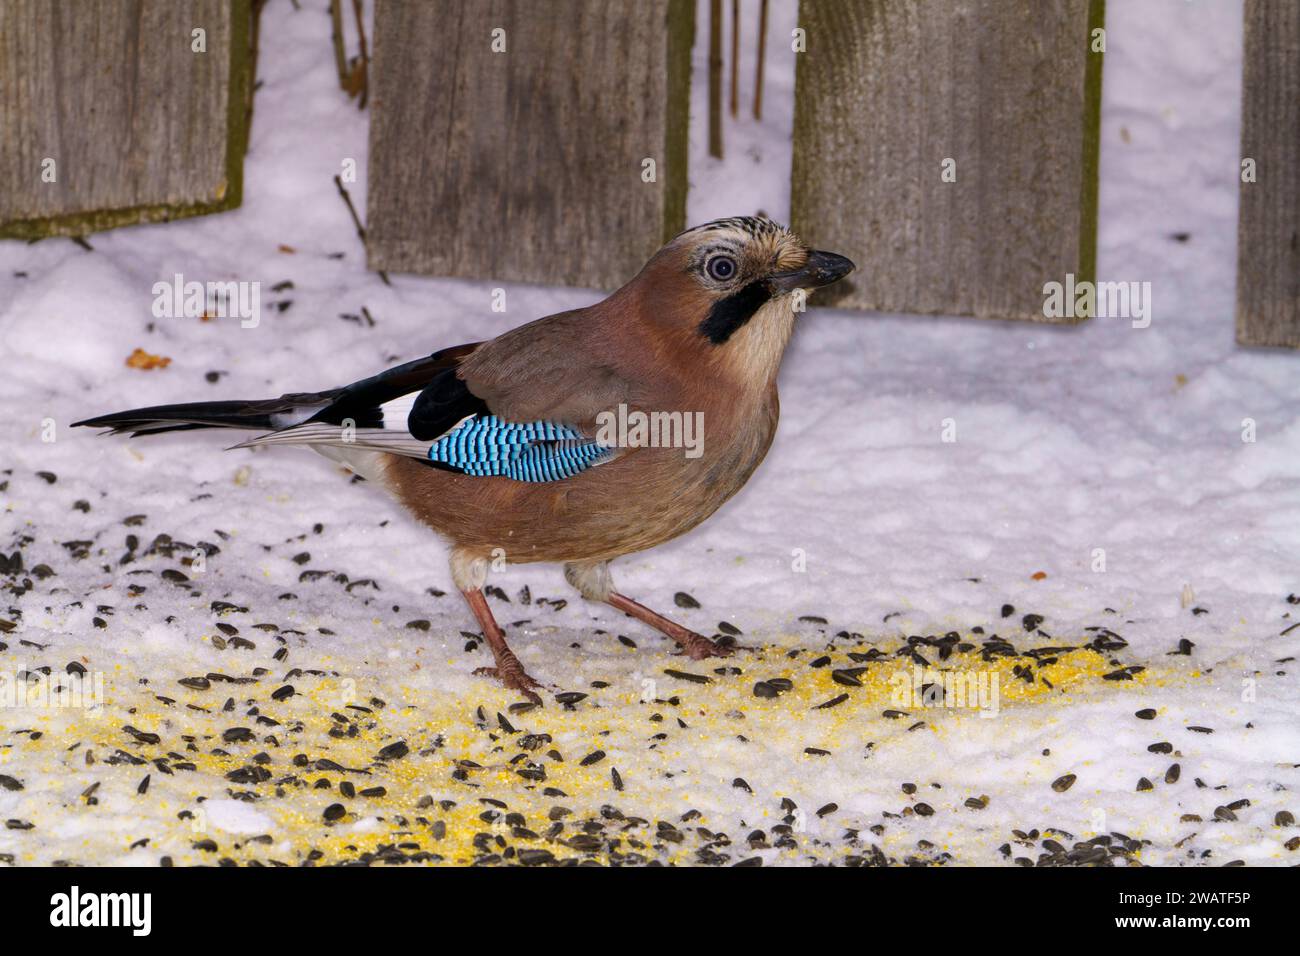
[{"x1": 429, "y1": 415, "x2": 612, "y2": 481}]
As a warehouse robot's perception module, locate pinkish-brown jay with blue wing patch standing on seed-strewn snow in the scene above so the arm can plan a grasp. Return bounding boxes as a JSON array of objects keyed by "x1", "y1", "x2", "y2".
[{"x1": 74, "y1": 216, "x2": 855, "y2": 705}]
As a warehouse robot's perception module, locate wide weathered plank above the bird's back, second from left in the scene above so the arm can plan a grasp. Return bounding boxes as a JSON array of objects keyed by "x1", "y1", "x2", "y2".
[{"x1": 367, "y1": 0, "x2": 694, "y2": 289}]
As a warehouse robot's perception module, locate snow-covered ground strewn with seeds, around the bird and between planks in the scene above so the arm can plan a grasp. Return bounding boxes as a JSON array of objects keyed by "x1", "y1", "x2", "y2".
[{"x1": 0, "y1": 0, "x2": 1300, "y2": 865}]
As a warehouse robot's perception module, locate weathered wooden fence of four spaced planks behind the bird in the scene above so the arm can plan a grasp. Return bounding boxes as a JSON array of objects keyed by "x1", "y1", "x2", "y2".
[{"x1": 0, "y1": 0, "x2": 1300, "y2": 346}]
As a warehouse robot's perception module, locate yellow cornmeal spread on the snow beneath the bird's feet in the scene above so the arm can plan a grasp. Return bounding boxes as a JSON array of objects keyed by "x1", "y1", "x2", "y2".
[{"x1": 10, "y1": 637, "x2": 1170, "y2": 865}]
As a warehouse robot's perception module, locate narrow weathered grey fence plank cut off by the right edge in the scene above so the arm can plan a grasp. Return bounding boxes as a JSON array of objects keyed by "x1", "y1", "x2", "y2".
[{"x1": 1236, "y1": 0, "x2": 1300, "y2": 347}]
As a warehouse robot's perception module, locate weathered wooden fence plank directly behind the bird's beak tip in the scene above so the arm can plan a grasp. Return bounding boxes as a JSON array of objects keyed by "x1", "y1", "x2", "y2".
[{"x1": 790, "y1": 0, "x2": 1102, "y2": 321}]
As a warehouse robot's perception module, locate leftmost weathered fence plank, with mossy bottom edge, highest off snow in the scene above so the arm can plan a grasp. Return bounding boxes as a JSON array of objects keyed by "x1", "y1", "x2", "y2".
[{"x1": 0, "y1": 0, "x2": 250, "y2": 238}]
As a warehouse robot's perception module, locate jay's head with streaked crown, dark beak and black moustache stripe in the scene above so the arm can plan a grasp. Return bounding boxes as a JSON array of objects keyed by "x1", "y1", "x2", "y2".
[{"x1": 626, "y1": 216, "x2": 855, "y2": 380}]
